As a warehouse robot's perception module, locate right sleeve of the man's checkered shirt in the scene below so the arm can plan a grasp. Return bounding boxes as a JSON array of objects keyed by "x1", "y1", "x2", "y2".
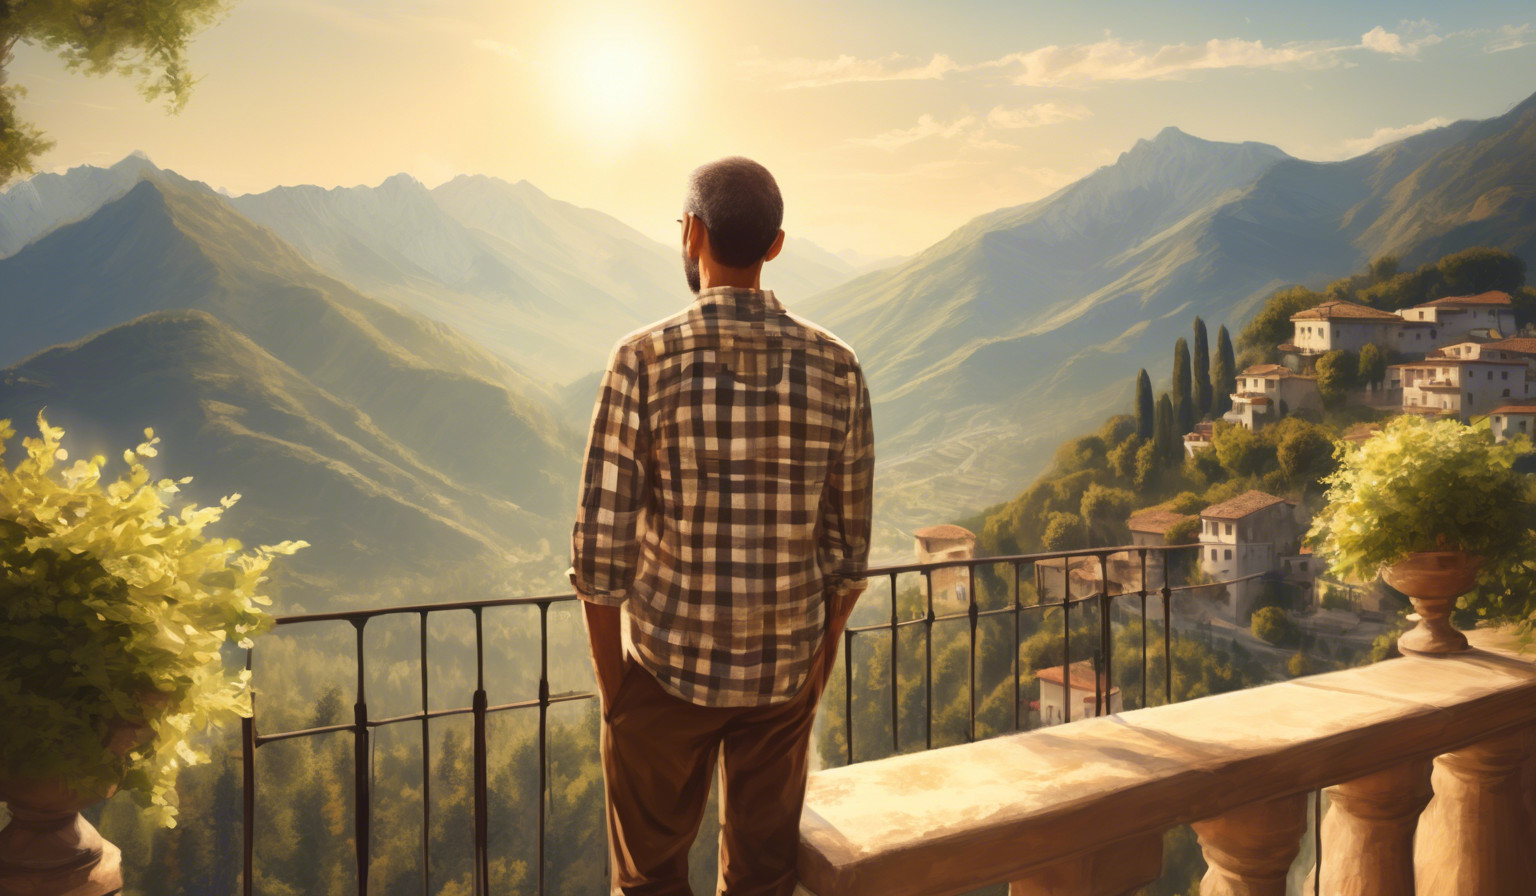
[{"x1": 817, "y1": 364, "x2": 874, "y2": 592}]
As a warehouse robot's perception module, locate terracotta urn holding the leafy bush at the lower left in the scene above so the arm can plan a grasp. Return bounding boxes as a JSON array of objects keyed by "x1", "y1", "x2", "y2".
[{"x1": 0, "y1": 719, "x2": 153, "y2": 896}]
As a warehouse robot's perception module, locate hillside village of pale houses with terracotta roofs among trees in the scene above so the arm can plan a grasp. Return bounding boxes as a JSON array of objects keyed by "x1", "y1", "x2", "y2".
[{"x1": 914, "y1": 252, "x2": 1536, "y2": 673}]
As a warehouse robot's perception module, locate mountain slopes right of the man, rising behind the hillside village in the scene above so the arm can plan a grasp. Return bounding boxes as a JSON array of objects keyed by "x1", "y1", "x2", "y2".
[{"x1": 803, "y1": 97, "x2": 1536, "y2": 544}]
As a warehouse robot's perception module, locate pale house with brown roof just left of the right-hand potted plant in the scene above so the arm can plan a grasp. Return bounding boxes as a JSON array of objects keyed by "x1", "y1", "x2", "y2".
[{"x1": 1200, "y1": 490, "x2": 1304, "y2": 626}]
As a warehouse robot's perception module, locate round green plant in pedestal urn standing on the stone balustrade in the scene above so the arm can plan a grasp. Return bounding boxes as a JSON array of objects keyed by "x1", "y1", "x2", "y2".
[{"x1": 1307, "y1": 415, "x2": 1533, "y2": 655}]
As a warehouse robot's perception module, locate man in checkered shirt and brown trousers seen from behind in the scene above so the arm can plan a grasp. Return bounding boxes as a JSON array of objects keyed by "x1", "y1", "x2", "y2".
[{"x1": 571, "y1": 158, "x2": 874, "y2": 896}]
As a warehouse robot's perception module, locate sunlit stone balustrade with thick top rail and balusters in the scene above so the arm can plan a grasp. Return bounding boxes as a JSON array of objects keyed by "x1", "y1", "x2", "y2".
[{"x1": 800, "y1": 633, "x2": 1536, "y2": 896}]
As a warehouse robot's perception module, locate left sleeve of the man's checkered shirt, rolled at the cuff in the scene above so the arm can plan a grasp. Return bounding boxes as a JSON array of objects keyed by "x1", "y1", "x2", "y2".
[{"x1": 571, "y1": 344, "x2": 648, "y2": 606}]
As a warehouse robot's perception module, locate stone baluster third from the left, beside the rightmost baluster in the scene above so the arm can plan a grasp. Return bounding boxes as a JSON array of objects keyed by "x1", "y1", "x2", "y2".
[{"x1": 1304, "y1": 759, "x2": 1430, "y2": 896}]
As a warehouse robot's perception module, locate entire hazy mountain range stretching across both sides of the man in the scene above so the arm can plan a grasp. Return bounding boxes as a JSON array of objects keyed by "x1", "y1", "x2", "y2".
[{"x1": 0, "y1": 89, "x2": 1536, "y2": 601}]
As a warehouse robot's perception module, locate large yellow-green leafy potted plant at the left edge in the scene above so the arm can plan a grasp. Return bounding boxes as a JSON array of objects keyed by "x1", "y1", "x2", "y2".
[{"x1": 0, "y1": 415, "x2": 304, "y2": 893}]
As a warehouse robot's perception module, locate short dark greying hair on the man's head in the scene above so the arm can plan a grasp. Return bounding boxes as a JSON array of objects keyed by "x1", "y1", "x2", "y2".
[{"x1": 684, "y1": 155, "x2": 783, "y2": 267}]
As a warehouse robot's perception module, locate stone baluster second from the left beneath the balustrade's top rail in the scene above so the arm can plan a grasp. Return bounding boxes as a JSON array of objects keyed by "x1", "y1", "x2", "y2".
[{"x1": 1192, "y1": 793, "x2": 1307, "y2": 896}]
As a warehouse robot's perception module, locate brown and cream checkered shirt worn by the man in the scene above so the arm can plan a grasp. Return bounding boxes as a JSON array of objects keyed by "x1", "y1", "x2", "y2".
[{"x1": 571, "y1": 287, "x2": 874, "y2": 707}]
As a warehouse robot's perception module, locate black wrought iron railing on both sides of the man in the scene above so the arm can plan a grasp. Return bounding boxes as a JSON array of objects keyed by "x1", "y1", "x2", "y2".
[{"x1": 241, "y1": 544, "x2": 1260, "y2": 896}]
